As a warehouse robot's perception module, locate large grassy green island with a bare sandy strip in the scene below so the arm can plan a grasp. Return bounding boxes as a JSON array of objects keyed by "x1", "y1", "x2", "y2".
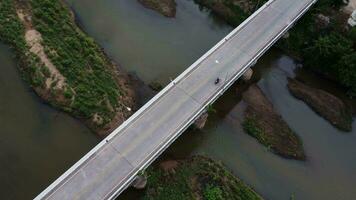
[{"x1": 0, "y1": 0, "x2": 135, "y2": 135}]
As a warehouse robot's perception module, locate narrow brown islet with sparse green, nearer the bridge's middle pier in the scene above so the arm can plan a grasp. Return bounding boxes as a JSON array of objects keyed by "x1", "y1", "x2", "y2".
[{"x1": 242, "y1": 84, "x2": 305, "y2": 160}]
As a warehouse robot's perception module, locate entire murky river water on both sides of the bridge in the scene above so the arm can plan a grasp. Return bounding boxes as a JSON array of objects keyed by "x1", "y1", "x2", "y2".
[{"x1": 0, "y1": 0, "x2": 356, "y2": 200}]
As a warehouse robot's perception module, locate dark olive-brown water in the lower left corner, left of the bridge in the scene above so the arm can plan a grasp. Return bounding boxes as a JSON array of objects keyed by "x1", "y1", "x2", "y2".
[{"x1": 0, "y1": 44, "x2": 98, "y2": 199}]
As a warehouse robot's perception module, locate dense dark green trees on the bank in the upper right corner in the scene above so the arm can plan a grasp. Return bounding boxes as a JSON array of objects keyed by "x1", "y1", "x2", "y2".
[{"x1": 278, "y1": 0, "x2": 356, "y2": 96}]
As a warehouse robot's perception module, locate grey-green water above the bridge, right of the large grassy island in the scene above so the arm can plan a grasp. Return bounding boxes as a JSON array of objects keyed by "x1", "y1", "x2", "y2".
[{"x1": 67, "y1": 0, "x2": 232, "y2": 84}]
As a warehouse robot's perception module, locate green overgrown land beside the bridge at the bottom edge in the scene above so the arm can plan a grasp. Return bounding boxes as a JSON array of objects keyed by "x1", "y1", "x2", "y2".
[{"x1": 144, "y1": 156, "x2": 262, "y2": 200}]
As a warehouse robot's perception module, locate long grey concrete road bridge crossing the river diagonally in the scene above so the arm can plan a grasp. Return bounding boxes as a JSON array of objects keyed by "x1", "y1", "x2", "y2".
[{"x1": 35, "y1": 0, "x2": 316, "y2": 200}]
